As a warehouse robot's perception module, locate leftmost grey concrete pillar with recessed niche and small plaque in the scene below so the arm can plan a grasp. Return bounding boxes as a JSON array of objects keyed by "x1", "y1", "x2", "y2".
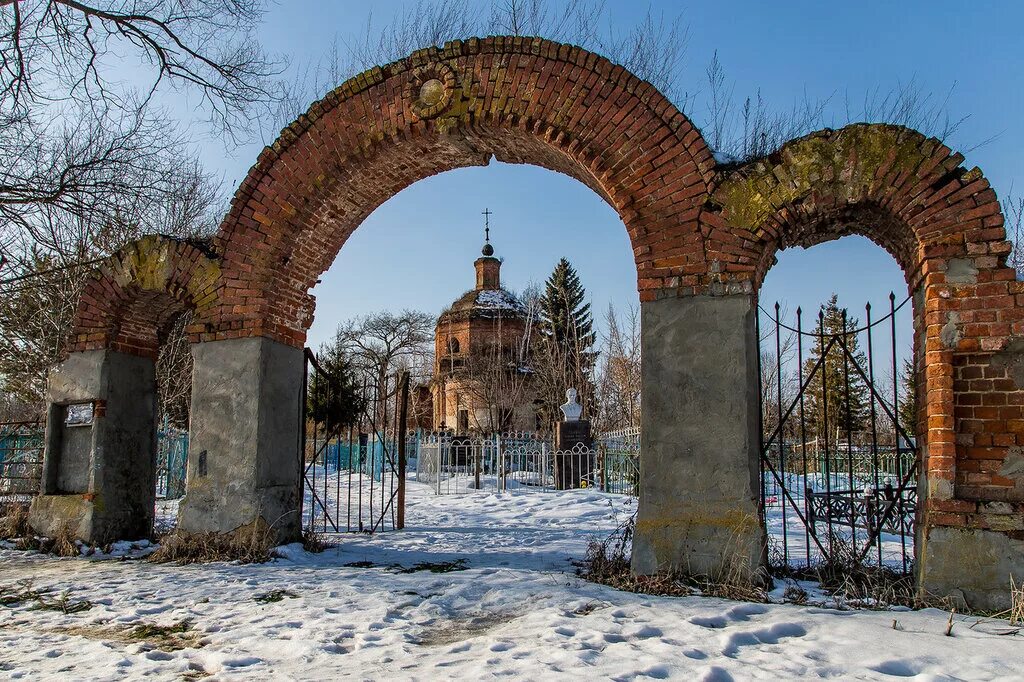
[{"x1": 29, "y1": 350, "x2": 157, "y2": 544}]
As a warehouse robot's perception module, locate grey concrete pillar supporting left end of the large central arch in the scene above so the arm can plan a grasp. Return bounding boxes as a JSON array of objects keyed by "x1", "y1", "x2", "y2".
[{"x1": 178, "y1": 338, "x2": 303, "y2": 542}]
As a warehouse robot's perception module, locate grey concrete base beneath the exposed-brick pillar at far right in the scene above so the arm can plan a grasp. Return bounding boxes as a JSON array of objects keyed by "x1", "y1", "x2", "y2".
[{"x1": 916, "y1": 526, "x2": 1024, "y2": 611}]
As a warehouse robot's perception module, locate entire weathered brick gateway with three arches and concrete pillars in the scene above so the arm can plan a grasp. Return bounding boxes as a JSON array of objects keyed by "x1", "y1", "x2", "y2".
[{"x1": 34, "y1": 38, "x2": 1024, "y2": 604}]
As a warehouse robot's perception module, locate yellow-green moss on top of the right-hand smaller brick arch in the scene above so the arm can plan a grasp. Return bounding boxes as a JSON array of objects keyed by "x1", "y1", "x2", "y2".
[{"x1": 714, "y1": 124, "x2": 939, "y2": 231}]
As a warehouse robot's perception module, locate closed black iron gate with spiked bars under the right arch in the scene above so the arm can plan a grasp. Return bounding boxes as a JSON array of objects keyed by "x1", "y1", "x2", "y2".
[{"x1": 758, "y1": 294, "x2": 919, "y2": 572}]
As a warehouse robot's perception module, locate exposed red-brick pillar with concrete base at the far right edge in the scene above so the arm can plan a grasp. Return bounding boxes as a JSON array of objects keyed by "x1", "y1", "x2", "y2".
[{"x1": 915, "y1": 256, "x2": 1024, "y2": 610}]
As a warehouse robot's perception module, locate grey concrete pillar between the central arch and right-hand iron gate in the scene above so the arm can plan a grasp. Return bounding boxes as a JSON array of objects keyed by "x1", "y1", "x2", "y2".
[{"x1": 633, "y1": 295, "x2": 766, "y2": 580}]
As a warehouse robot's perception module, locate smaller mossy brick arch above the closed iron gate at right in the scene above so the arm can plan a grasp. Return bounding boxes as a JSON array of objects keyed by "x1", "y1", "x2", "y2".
[{"x1": 713, "y1": 124, "x2": 1010, "y2": 291}]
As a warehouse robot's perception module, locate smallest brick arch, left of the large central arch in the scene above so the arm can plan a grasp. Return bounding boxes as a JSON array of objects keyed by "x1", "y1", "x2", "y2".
[{"x1": 69, "y1": 235, "x2": 221, "y2": 357}]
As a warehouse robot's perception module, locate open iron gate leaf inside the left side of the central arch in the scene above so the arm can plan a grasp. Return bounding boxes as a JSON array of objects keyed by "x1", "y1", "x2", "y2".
[{"x1": 299, "y1": 348, "x2": 409, "y2": 532}]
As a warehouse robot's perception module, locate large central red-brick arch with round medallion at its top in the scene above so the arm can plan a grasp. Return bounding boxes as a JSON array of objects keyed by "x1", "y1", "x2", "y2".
[{"x1": 216, "y1": 38, "x2": 714, "y2": 345}]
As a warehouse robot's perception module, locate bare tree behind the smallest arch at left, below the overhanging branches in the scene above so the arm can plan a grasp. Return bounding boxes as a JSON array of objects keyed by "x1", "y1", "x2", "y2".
[{"x1": 0, "y1": 159, "x2": 221, "y2": 426}]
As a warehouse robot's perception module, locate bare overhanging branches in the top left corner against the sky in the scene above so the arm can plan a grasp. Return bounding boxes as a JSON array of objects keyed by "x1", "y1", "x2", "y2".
[{"x1": 0, "y1": 0, "x2": 282, "y2": 136}]
